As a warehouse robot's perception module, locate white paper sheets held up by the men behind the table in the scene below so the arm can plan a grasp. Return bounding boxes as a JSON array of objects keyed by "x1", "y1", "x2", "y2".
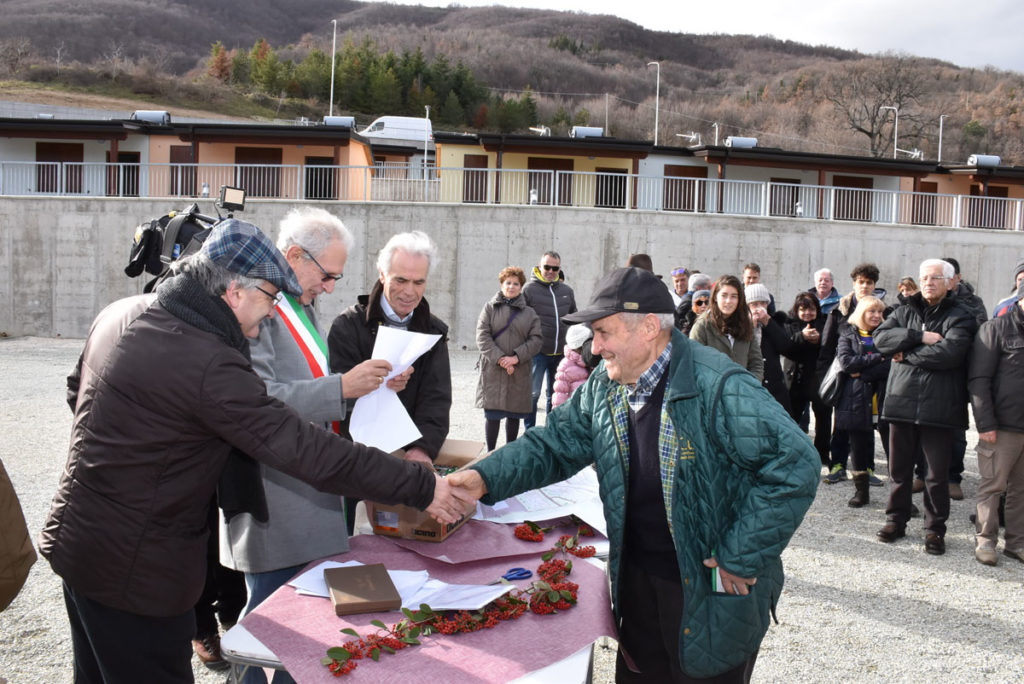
[{"x1": 348, "y1": 326, "x2": 441, "y2": 453}]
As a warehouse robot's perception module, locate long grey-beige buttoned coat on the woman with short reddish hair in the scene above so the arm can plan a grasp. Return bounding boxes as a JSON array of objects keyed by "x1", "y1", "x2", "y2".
[{"x1": 476, "y1": 292, "x2": 544, "y2": 414}]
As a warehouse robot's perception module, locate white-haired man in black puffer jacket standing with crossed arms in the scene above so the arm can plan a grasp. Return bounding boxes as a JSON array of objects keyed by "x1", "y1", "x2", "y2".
[{"x1": 874, "y1": 259, "x2": 977, "y2": 555}]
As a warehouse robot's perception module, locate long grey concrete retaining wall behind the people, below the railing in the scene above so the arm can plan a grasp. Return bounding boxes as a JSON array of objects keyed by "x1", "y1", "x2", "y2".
[{"x1": 0, "y1": 198, "x2": 1024, "y2": 348}]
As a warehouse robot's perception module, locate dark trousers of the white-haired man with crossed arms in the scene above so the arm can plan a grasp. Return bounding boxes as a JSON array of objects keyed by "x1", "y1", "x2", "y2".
[{"x1": 886, "y1": 423, "x2": 956, "y2": 537}]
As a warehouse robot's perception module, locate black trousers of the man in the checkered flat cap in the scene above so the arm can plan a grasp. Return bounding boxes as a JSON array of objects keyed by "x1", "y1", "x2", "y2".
[{"x1": 63, "y1": 583, "x2": 196, "y2": 684}]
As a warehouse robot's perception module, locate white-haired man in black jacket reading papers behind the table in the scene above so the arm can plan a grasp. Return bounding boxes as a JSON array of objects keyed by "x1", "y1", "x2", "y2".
[{"x1": 327, "y1": 230, "x2": 452, "y2": 533}]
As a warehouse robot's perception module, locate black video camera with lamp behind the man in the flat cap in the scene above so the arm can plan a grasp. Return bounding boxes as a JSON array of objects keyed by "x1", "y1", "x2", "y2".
[{"x1": 125, "y1": 185, "x2": 246, "y2": 292}]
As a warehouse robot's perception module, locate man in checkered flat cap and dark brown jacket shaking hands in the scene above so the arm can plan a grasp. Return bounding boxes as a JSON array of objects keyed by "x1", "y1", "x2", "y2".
[{"x1": 39, "y1": 219, "x2": 471, "y2": 684}]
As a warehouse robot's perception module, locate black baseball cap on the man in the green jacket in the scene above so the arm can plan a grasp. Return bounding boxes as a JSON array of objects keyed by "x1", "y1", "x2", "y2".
[{"x1": 562, "y1": 266, "x2": 676, "y2": 324}]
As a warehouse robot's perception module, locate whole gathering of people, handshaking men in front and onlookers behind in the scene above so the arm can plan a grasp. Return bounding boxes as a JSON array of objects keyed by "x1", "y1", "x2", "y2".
[{"x1": 0, "y1": 208, "x2": 1024, "y2": 684}]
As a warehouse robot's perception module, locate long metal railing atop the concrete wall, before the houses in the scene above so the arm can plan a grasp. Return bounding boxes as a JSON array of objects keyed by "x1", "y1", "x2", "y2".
[{"x1": 0, "y1": 162, "x2": 1024, "y2": 230}]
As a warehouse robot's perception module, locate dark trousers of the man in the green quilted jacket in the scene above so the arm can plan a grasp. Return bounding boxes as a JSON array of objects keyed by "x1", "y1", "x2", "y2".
[{"x1": 615, "y1": 559, "x2": 758, "y2": 684}]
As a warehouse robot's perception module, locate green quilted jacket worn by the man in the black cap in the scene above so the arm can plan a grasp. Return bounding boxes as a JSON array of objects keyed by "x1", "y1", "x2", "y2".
[{"x1": 474, "y1": 331, "x2": 820, "y2": 677}]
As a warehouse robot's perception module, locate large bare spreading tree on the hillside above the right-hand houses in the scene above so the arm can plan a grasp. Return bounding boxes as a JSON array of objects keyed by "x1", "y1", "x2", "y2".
[{"x1": 823, "y1": 55, "x2": 927, "y2": 157}]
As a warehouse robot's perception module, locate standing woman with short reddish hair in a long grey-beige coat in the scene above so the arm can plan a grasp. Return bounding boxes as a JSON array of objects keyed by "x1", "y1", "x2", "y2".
[{"x1": 476, "y1": 266, "x2": 544, "y2": 452}]
